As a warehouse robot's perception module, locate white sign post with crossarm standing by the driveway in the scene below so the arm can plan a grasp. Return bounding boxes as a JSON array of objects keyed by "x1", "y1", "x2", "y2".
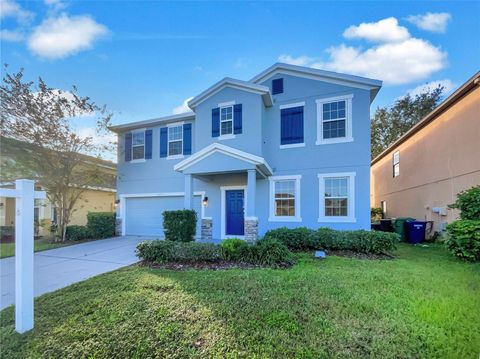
[{"x1": 0, "y1": 179, "x2": 46, "y2": 333}]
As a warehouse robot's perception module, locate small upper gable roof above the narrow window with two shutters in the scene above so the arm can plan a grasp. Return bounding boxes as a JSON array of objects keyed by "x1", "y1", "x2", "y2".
[{"x1": 188, "y1": 77, "x2": 273, "y2": 110}]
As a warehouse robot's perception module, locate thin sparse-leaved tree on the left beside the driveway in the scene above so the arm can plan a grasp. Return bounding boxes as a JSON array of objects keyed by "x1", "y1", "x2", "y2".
[{"x1": 0, "y1": 65, "x2": 113, "y2": 241}]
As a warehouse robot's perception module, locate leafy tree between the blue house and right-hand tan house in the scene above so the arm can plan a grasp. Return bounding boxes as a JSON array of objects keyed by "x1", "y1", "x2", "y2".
[{"x1": 371, "y1": 85, "x2": 445, "y2": 159}]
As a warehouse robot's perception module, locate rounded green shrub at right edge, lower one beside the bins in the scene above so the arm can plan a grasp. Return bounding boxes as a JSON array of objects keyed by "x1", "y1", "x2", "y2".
[{"x1": 445, "y1": 220, "x2": 480, "y2": 261}]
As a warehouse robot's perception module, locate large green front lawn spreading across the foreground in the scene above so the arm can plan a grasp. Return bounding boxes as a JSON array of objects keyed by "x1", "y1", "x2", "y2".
[{"x1": 0, "y1": 245, "x2": 480, "y2": 358}]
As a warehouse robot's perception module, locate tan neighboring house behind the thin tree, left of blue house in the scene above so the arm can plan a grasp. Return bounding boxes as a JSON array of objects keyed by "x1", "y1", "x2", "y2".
[{"x1": 0, "y1": 137, "x2": 116, "y2": 235}]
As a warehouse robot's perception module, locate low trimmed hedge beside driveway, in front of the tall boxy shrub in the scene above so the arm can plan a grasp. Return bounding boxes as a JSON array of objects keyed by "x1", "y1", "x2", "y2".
[{"x1": 137, "y1": 240, "x2": 221, "y2": 263}]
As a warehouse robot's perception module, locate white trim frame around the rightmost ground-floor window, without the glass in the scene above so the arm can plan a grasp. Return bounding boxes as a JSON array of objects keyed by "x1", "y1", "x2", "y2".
[{"x1": 317, "y1": 172, "x2": 357, "y2": 223}]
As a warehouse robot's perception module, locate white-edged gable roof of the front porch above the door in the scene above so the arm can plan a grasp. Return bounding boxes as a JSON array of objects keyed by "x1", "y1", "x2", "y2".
[{"x1": 173, "y1": 142, "x2": 273, "y2": 177}]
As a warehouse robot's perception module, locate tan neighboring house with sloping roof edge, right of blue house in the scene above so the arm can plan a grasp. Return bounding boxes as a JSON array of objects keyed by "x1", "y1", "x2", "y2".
[{"x1": 370, "y1": 72, "x2": 480, "y2": 232}]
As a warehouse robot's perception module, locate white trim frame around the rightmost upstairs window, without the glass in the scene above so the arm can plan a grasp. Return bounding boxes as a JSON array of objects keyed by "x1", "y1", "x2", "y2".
[{"x1": 315, "y1": 94, "x2": 353, "y2": 145}]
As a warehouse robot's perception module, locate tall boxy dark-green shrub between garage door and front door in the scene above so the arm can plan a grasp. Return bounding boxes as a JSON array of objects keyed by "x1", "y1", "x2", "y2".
[{"x1": 163, "y1": 209, "x2": 197, "y2": 242}]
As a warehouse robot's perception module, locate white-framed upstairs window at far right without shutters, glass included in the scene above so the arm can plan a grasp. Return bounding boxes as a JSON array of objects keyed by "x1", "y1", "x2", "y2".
[{"x1": 316, "y1": 95, "x2": 353, "y2": 145}]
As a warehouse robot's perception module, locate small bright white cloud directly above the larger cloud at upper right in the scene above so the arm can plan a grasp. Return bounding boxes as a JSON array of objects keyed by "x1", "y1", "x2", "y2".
[{"x1": 343, "y1": 17, "x2": 410, "y2": 42}]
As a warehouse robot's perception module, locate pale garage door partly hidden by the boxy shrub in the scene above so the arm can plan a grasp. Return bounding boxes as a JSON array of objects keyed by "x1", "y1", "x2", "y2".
[{"x1": 125, "y1": 196, "x2": 202, "y2": 238}]
